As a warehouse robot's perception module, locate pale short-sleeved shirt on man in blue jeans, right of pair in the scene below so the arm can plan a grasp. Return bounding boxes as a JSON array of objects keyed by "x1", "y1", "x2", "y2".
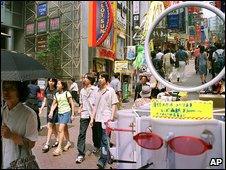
[{"x1": 95, "y1": 86, "x2": 118, "y2": 129}]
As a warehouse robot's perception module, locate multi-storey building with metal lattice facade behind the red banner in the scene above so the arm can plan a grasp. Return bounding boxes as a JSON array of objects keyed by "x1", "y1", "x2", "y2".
[{"x1": 1, "y1": 1, "x2": 132, "y2": 79}]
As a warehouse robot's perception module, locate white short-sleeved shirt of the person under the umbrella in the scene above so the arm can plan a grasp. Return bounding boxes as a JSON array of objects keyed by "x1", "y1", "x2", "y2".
[{"x1": 2, "y1": 103, "x2": 38, "y2": 169}]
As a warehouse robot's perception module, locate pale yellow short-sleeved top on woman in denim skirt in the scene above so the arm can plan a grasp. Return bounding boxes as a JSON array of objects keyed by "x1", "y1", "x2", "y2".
[{"x1": 54, "y1": 91, "x2": 72, "y2": 114}]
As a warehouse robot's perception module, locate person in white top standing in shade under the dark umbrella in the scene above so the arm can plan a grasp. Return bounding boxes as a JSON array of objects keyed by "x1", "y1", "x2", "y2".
[{"x1": 1, "y1": 81, "x2": 38, "y2": 169}]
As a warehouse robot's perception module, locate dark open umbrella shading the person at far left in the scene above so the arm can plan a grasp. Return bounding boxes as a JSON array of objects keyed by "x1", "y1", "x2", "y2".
[{"x1": 1, "y1": 49, "x2": 54, "y2": 81}]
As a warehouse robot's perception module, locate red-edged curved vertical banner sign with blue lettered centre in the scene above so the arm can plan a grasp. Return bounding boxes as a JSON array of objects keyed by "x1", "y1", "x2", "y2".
[{"x1": 88, "y1": 1, "x2": 113, "y2": 47}]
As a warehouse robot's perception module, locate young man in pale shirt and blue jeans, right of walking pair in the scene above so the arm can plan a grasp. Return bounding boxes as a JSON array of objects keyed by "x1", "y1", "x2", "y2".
[{"x1": 90, "y1": 73, "x2": 118, "y2": 169}]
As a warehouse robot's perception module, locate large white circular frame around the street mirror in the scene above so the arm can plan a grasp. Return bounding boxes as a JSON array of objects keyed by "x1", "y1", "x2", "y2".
[{"x1": 144, "y1": 1, "x2": 225, "y2": 92}]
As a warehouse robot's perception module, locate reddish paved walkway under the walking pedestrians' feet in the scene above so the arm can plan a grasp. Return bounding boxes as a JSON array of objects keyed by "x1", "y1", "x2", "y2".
[{"x1": 33, "y1": 98, "x2": 133, "y2": 169}]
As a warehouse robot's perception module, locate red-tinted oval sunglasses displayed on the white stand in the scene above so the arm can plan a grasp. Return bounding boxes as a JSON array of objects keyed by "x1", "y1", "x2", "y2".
[{"x1": 105, "y1": 121, "x2": 213, "y2": 156}]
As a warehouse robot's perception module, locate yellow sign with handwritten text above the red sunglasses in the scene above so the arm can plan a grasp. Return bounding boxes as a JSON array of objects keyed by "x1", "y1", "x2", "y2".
[{"x1": 150, "y1": 99, "x2": 213, "y2": 120}]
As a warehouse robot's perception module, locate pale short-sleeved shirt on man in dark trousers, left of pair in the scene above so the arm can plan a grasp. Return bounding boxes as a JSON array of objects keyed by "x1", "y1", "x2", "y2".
[{"x1": 79, "y1": 86, "x2": 98, "y2": 119}]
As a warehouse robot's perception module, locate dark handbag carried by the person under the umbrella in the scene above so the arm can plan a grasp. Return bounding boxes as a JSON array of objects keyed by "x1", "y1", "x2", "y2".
[{"x1": 8, "y1": 138, "x2": 40, "y2": 169}]
